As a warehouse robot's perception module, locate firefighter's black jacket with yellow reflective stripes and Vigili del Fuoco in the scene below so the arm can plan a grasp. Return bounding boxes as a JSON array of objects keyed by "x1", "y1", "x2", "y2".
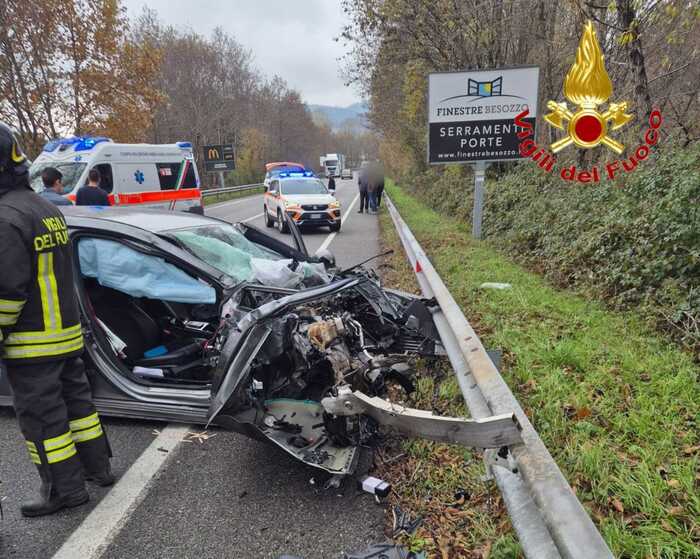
[{"x1": 0, "y1": 188, "x2": 83, "y2": 362}]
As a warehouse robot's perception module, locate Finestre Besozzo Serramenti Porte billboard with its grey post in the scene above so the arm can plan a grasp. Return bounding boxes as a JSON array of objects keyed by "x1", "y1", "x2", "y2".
[{"x1": 428, "y1": 66, "x2": 539, "y2": 239}]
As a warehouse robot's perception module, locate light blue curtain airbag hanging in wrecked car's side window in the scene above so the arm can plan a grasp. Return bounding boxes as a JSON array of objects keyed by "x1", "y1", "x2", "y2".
[{"x1": 78, "y1": 239, "x2": 216, "y2": 304}]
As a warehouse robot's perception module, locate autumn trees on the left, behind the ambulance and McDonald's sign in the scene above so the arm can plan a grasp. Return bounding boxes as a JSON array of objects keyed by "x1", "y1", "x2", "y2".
[{"x1": 0, "y1": 0, "x2": 372, "y2": 187}]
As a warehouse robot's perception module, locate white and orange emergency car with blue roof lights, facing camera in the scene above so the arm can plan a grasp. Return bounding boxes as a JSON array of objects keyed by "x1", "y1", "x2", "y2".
[{"x1": 263, "y1": 170, "x2": 341, "y2": 233}]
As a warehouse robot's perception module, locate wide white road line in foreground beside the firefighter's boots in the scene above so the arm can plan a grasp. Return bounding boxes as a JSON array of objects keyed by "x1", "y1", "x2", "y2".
[{"x1": 52, "y1": 425, "x2": 192, "y2": 559}]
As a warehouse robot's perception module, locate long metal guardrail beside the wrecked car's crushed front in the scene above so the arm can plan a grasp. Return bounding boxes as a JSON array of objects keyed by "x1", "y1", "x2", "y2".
[{"x1": 386, "y1": 196, "x2": 613, "y2": 559}]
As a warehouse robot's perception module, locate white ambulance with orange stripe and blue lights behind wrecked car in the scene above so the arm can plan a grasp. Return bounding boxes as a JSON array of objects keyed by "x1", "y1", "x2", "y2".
[{"x1": 29, "y1": 136, "x2": 203, "y2": 214}]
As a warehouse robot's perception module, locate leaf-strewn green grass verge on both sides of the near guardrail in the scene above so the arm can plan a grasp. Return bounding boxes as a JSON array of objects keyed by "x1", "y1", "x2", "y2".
[{"x1": 378, "y1": 184, "x2": 700, "y2": 559}]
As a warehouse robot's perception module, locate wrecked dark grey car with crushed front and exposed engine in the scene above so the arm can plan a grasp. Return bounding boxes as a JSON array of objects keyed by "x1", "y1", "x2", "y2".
[{"x1": 0, "y1": 208, "x2": 519, "y2": 474}]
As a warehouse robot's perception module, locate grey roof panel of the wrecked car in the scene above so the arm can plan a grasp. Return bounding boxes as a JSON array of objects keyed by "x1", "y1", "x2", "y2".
[{"x1": 59, "y1": 206, "x2": 221, "y2": 234}]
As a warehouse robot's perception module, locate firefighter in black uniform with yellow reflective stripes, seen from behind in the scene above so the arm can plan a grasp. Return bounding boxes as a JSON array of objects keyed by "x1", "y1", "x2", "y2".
[{"x1": 0, "y1": 122, "x2": 114, "y2": 516}]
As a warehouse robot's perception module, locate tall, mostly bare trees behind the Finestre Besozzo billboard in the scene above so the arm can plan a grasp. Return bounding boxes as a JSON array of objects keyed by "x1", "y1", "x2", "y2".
[{"x1": 344, "y1": 0, "x2": 700, "y2": 172}]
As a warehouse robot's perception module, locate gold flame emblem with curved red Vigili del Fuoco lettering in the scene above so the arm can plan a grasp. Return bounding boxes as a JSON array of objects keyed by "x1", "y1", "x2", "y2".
[{"x1": 515, "y1": 21, "x2": 663, "y2": 183}]
